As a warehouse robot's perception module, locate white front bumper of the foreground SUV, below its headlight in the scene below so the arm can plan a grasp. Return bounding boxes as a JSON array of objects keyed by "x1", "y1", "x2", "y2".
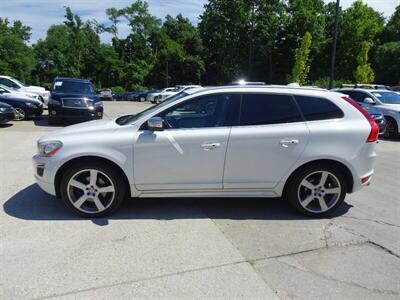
[{"x1": 32, "y1": 155, "x2": 56, "y2": 196}]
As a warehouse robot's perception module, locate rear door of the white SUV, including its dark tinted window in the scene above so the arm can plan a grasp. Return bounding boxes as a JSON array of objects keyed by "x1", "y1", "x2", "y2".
[{"x1": 223, "y1": 94, "x2": 309, "y2": 189}]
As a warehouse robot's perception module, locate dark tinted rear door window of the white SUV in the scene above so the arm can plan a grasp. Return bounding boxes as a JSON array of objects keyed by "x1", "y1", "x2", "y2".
[{"x1": 240, "y1": 94, "x2": 302, "y2": 125}]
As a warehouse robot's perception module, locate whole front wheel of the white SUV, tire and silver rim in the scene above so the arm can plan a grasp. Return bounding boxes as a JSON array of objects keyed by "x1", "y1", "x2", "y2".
[{"x1": 60, "y1": 162, "x2": 127, "y2": 218}]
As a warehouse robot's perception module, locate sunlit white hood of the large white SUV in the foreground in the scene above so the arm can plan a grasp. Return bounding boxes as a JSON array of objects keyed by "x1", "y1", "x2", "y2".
[{"x1": 39, "y1": 120, "x2": 120, "y2": 141}]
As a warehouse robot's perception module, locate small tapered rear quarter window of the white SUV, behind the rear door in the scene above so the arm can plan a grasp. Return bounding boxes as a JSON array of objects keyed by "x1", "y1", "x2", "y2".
[{"x1": 295, "y1": 96, "x2": 343, "y2": 121}]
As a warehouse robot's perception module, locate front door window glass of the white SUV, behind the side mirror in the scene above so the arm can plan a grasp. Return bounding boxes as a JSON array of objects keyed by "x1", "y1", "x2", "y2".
[{"x1": 159, "y1": 94, "x2": 240, "y2": 128}]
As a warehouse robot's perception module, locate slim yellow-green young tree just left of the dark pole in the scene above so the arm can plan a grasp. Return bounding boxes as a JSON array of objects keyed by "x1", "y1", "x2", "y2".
[{"x1": 289, "y1": 32, "x2": 312, "y2": 85}]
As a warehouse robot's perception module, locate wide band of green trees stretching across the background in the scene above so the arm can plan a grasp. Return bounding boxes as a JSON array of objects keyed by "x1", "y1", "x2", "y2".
[{"x1": 0, "y1": 0, "x2": 400, "y2": 90}]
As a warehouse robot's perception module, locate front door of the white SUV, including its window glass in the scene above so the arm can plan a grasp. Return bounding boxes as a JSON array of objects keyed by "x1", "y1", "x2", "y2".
[{"x1": 134, "y1": 94, "x2": 239, "y2": 191}]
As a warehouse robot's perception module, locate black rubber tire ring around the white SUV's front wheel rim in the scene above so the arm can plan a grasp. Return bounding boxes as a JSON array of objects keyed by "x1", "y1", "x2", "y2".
[{"x1": 60, "y1": 160, "x2": 128, "y2": 218}]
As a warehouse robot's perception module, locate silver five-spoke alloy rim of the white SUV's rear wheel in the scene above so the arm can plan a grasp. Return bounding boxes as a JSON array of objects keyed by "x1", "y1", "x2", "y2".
[{"x1": 297, "y1": 171, "x2": 342, "y2": 213}]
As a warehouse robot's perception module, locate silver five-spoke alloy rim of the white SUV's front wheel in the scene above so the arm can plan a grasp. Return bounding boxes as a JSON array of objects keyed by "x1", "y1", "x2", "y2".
[{"x1": 67, "y1": 169, "x2": 115, "y2": 214}]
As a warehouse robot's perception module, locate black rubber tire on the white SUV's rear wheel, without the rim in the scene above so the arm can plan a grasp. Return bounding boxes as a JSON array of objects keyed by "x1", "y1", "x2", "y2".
[{"x1": 283, "y1": 163, "x2": 347, "y2": 217}]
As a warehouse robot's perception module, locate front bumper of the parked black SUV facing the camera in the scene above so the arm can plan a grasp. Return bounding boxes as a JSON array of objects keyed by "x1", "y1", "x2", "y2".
[{"x1": 48, "y1": 105, "x2": 103, "y2": 120}]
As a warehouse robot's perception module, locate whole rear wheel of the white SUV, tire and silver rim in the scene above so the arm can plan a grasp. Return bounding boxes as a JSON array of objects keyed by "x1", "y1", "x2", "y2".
[{"x1": 284, "y1": 165, "x2": 347, "y2": 217}]
